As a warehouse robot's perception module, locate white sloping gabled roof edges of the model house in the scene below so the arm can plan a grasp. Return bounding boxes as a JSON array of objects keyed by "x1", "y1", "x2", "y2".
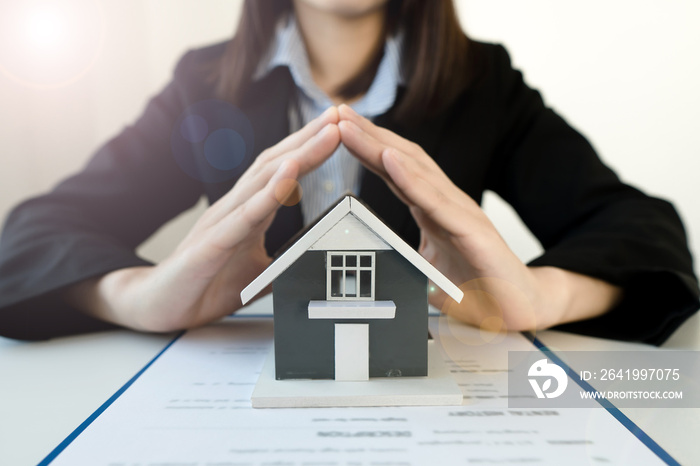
[{"x1": 241, "y1": 196, "x2": 464, "y2": 304}]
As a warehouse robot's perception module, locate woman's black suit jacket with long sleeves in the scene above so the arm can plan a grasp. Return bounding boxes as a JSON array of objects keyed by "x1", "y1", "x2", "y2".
[{"x1": 0, "y1": 42, "x2": 698, "y2": 344}]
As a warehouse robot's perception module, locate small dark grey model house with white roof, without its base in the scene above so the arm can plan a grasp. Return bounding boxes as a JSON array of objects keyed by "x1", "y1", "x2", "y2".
[{"x1": 241, "y1": 196, "x2": 462, "y2": 380}]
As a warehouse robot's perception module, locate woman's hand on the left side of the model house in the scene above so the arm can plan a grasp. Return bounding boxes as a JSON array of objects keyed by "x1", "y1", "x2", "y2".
[{"x1": 65, "y1": 107, "x2": 340, "y2": 332}]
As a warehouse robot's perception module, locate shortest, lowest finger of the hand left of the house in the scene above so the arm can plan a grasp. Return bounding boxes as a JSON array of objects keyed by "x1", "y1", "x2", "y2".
[{"x1": 210, "y1": 160, "x2": 299, "y2": 251}]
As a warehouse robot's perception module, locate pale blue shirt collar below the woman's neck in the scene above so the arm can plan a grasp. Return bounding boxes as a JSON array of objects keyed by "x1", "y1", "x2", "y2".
[{"x1": 253, "y1": 14, "x2": 405, "y2": 117}]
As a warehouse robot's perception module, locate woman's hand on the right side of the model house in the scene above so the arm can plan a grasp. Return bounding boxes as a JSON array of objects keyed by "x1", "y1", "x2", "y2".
[{"x1": 338, "y1": 105, "x2": 620, "y2": 330}]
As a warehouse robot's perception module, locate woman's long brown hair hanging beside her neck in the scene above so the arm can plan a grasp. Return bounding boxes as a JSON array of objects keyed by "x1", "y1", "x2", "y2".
[{"x1": 215, "y1": 0, "x2": 470, "y2": 121}]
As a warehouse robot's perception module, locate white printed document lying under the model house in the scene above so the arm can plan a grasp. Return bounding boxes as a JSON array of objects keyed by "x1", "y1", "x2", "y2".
[{"x1": 45, "y1": 316, "x2": 664, "y2": 466}]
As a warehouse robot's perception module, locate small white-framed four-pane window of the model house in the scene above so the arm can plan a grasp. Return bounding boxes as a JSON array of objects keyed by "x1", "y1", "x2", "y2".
[{"x1": 326, "y1": 251, "x2": 374, "y2": 301}]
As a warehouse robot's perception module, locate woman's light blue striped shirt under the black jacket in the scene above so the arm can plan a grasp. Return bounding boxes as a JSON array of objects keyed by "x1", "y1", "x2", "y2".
[{"x1": 253, "y1": 15, "x2": 404, "y2": 225}]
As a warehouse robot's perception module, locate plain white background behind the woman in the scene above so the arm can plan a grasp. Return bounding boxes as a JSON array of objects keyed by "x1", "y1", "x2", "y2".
[{"x1": 0, "y1": 0, "x2": 700, "y2": 290}]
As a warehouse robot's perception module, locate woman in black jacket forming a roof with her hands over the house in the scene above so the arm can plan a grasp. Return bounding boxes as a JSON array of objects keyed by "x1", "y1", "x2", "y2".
[{"x1": 0, "y1": 0, "x2": 698, "y2": 343}]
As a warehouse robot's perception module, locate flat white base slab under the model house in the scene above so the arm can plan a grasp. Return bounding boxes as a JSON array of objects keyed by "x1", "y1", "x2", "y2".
[{"x1": 251, "y1": 340, "x2": 462, "y2": 408}]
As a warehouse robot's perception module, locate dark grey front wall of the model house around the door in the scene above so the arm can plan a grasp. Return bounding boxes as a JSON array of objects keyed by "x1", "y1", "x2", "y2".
[{"x1": 272, "y1": 250, "x2": 428, "y2": 379}]
